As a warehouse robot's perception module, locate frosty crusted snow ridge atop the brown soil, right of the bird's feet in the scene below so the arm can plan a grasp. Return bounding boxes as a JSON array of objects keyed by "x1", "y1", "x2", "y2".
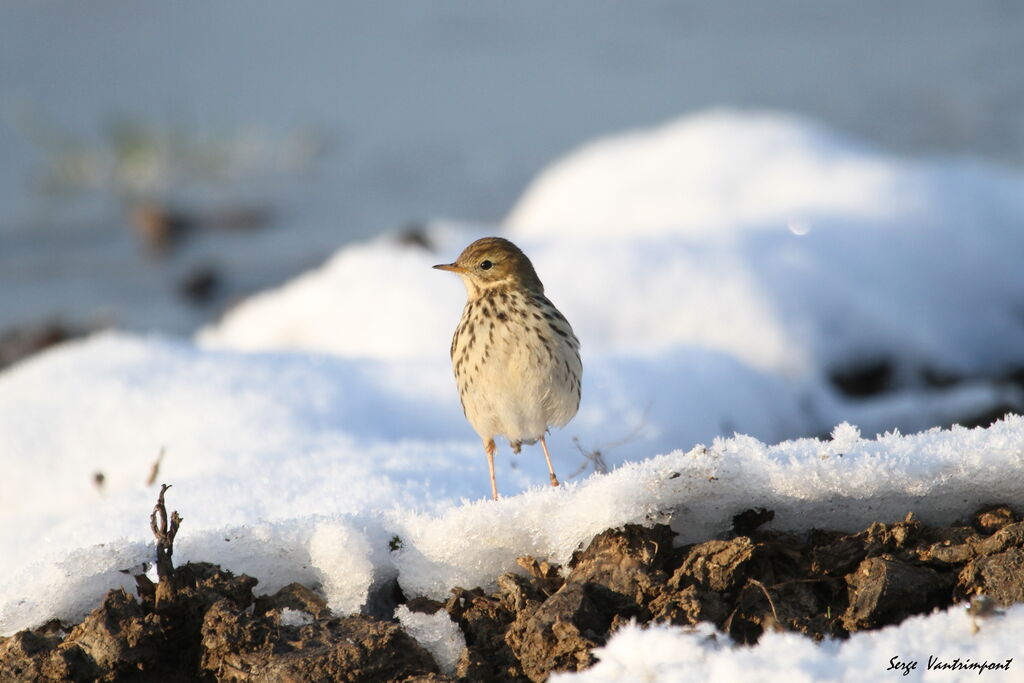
[{"x1": 393, "y1": 417, "x2": 1024, "y2": 599}]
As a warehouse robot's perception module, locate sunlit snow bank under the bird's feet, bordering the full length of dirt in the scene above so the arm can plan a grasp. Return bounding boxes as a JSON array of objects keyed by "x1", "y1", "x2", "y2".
[{"x1": 6, "y1": 325, "x2": 1024, "y2": 633}]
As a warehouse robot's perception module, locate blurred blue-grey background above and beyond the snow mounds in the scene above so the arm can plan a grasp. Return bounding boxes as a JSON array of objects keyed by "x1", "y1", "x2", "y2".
[{"x1": 0, "y1": 0, "x2": 1024, "y2": 367}]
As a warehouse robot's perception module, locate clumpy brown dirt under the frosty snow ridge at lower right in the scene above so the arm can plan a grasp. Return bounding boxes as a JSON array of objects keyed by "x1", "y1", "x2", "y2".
[{"x1": 432, "y1": 506, "x2": 1024, "y2": 681}]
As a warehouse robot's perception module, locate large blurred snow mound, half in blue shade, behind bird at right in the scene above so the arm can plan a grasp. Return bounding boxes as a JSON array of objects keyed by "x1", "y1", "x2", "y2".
[{"x1": 506, "y1": 111, "x2": 1024, "y2": 382}]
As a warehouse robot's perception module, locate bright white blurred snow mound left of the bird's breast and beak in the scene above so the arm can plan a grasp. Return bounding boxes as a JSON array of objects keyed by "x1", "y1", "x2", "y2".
[{"x1": 198, "y1": 223, "x2": 483, "y2": 358}]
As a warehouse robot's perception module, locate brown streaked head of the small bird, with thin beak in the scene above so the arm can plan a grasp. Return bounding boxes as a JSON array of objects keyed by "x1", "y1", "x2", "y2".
[{"x1": 434, "y1": 238, "x2": 544, "y2": 299}]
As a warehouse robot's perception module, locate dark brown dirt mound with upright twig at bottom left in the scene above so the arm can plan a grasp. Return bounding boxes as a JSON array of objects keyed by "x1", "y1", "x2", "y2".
[{"x1": 0, "y1": 563, "x2": 437, "y2": 682}]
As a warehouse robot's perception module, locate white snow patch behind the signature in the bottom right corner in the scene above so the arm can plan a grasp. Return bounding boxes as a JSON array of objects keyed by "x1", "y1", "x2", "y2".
[{"x1": 550, "y1": 605, "x2": 1024, "y2": 683}]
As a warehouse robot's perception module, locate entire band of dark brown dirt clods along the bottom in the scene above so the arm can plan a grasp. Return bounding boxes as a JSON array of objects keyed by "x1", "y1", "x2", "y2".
[{"x1": 0, "y1": 506, "x2": 1024, "y2": 681}]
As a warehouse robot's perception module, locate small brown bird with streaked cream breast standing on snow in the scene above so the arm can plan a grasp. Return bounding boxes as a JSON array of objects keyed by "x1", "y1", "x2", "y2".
[{"x1": 433, "y1": 237, "x2": 583, "y2": 500}]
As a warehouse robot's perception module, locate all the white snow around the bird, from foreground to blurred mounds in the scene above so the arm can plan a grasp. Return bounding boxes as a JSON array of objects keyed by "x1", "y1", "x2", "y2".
[{"x1": 0, "y1": 112, "x2": 1024, "y2": 680}]
